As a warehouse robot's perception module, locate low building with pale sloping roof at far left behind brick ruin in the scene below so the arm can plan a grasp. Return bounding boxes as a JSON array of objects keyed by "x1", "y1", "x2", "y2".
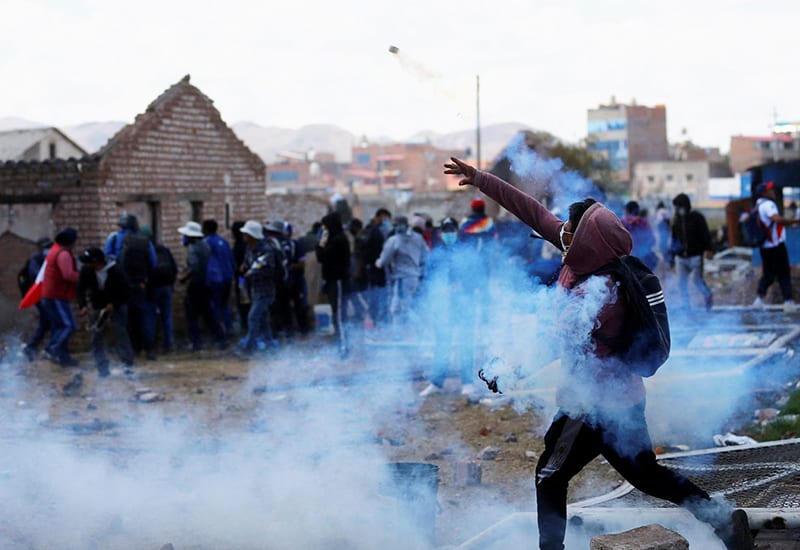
[{"x1": 0, "y1": 128, "x2": 88, "y2": 162}]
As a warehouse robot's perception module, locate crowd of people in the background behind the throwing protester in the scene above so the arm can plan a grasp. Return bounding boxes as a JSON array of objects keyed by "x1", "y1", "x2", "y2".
[{"x1": 14, "y1": 179, "x2": 800, "y2": 386}]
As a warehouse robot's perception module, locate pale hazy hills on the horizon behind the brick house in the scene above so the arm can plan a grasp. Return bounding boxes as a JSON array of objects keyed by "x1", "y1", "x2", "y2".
[{"x1": 0, "y1": 117, "x2": 530, "y2": 163}]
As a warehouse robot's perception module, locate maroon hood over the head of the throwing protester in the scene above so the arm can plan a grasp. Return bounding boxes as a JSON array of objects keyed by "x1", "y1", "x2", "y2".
[{"x1": 564, "y1": 203, "x2": 633, "y2": 276}]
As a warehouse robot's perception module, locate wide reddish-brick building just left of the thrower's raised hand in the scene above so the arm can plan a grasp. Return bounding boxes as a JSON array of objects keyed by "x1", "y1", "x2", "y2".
[{"x1": 343, "y1": 143, "x2": 463, "y2": 193}]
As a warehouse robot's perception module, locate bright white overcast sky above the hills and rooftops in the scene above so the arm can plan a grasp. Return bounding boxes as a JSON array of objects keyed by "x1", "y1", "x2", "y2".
[{"x1": 0, "y1": 0, "x2": 800, "y2": 151}]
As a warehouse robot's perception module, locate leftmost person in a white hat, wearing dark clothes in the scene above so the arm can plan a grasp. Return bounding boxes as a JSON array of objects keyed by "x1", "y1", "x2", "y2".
[{"x1": 178, "y1": 221, "x2": 225, "y2": 351}]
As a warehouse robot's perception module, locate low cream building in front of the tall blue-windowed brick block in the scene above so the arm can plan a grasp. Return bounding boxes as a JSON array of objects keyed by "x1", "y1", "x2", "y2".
[{"x1": 631, "y1": 160, "x2": 710, "y2": 204}]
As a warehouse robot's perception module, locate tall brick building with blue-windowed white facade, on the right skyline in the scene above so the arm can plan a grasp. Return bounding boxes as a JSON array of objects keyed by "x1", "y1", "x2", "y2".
[{"x1": 587, "y1": 98, "x2": 669, "y2": 182}]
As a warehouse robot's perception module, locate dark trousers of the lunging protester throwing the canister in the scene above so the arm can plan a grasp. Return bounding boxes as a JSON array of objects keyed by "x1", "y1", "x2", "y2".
[{"x1": 536, "y1": 402, "x2": 711, "y2": 550}]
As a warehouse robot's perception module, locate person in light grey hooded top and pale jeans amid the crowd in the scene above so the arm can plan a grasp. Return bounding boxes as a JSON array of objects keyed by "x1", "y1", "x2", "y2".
[{"x1": 375, "y1": 216, "x2": 429, "y2": 323}]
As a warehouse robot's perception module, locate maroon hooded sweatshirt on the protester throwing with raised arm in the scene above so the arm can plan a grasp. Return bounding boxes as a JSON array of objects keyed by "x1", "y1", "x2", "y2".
[{"x1": 474, "y1": 171, "x2": 645, "y2": 412}]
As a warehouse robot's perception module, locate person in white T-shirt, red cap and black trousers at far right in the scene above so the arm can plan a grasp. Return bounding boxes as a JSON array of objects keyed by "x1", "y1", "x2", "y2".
[{"x1": 753, "y1": 181, "x2": 800, "y2": 309}]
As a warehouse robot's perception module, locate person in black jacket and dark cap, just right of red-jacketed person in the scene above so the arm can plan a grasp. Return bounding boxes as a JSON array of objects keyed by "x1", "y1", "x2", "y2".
[{"x1": 78, "y1": 248, "x2": 133, "y2": 378}]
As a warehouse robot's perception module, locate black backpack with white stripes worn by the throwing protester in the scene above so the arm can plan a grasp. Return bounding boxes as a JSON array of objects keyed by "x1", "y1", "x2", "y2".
[{"x1": 594, "y1": 256, "x2": 671, "y2": 376}]
